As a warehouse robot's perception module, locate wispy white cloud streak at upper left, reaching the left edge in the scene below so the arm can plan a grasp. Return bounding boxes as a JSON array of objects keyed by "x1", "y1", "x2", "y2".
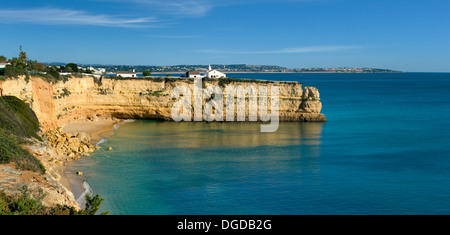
[{"x1": 0, "y1": 8, "x2": 162, "y2": 27}]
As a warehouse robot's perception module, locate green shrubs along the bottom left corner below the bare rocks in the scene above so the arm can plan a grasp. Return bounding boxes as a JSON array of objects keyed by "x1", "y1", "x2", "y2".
[{"x1": 0, "y1": 187, "x2": 109, "y2": 215}]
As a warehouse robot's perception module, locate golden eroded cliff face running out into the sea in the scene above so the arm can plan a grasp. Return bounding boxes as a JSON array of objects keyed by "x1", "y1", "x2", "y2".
[{"x1": 0, "y1": 77, "x2": 326, "y2": 131}]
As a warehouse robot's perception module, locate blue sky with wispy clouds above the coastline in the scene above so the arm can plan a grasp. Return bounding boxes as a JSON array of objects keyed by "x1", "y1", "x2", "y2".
[{"x1": 0, "y1": 0, "x2": 450, "y2": 72}]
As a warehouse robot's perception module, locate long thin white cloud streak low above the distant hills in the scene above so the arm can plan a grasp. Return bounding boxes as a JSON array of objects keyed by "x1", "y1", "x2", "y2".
[{"x1": 195, "y1": 46, "x2": 362, "y2": 55}]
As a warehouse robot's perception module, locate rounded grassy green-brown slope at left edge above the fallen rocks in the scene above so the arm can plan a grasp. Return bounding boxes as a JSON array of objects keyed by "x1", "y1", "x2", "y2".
[{"x1": 0, "y1": 96, "x2": 45, "y2": 173}]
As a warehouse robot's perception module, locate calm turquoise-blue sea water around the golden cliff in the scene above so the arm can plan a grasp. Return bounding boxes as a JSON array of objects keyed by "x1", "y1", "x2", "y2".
[{"x1": 70, "y1": 73, "x2": 450, "y2": 215}]
